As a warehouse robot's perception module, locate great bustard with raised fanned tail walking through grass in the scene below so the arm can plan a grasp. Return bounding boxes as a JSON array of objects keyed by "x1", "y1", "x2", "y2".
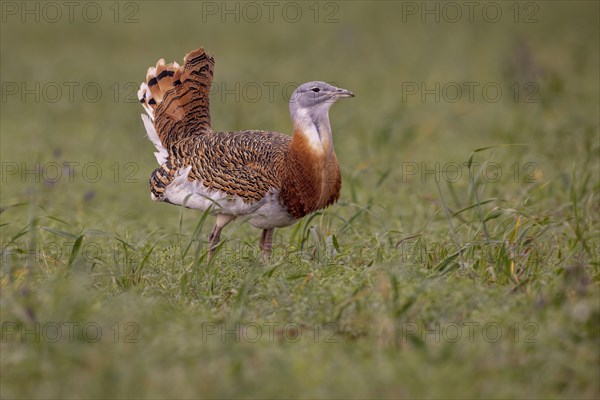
[{"x1": 138, "y1": 48, "x2": 354, "y2": 258}]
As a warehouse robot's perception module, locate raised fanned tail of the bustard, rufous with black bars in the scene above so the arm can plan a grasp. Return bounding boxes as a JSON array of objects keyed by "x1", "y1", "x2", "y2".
[{"x1": 138, "y1": 47, "x2": 215, "y2": 150}]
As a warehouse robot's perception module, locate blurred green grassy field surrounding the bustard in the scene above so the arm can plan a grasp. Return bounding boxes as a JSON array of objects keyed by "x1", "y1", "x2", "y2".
[{"x1": 0, "y1": 1, "x2": 600, "y2": 399}]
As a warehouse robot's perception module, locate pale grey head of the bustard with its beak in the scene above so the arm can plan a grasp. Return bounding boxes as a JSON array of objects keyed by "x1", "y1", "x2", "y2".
[{"x1": 290, "y1": 81, "x2": 354, "y2": 121}]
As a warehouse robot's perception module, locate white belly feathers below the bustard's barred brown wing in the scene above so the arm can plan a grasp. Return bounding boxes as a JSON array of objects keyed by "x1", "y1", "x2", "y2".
[{"x1": 152, "y1": 167, "x2": 296, "y2": 229}]
